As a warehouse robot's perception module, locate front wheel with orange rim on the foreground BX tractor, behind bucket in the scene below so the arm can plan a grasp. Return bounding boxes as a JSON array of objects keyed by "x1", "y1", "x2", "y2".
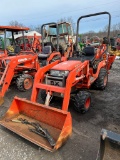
[{"x1": 73, "y1": 91, "x2": 91, "y2": 113}]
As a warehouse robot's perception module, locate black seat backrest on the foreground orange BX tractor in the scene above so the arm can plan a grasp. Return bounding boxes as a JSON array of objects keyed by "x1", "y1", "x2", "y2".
[{"x1": 83, "y1": 46, "x2": 96, "y2": 56}]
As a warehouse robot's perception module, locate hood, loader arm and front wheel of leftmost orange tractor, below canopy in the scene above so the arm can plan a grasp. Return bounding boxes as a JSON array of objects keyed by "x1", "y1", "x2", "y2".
[{"x1": 0, "y1": 51, "x2": 40, "y2": 103}]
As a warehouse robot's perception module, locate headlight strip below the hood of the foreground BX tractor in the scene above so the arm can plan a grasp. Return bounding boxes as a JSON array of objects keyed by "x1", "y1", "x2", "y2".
[{"x1": 50, "y1": 70, "x2": 69, "y2": 77}]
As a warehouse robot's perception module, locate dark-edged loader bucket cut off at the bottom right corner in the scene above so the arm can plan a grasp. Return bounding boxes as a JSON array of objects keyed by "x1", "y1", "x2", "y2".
[{"x1": 100, "y1": 129, "x2": 120, "y2": 160}]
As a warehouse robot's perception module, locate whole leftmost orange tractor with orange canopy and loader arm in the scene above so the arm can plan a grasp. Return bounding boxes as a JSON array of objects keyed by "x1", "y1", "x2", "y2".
[{"x1": 0, "y1": 26, "x2": 40, "y2": 104}]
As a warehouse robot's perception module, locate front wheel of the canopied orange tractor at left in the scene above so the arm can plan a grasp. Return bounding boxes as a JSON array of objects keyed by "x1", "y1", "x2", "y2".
[{"x1": 16, "y1": 74, "x2": 33, "y2": 92}]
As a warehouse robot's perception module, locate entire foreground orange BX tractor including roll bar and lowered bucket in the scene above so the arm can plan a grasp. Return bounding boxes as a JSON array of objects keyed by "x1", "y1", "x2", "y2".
[{"x1": 0, "y1": 12, "x2": 116, "y2": 151}]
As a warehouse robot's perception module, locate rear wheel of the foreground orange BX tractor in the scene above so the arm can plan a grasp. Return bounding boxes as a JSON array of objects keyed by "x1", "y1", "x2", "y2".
[{"x1": 93, "y1": 68, "x2": 108, "y2": 90}]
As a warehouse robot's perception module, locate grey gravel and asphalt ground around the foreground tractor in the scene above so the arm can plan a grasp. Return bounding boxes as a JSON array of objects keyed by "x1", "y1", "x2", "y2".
[{"x1": 0, "y1": 60, "x2": 120, "y2": 160}]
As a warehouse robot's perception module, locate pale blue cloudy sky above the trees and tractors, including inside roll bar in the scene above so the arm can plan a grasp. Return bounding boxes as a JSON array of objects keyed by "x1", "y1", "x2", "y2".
[{"x1": 0, "y1": 0, "x2": 120, "y2": 32}]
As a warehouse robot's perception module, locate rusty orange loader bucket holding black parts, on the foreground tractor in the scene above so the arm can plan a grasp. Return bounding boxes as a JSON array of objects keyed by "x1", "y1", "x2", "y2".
[{"x1": 0, "y1": 97, "x2": 72, "y2": 152}]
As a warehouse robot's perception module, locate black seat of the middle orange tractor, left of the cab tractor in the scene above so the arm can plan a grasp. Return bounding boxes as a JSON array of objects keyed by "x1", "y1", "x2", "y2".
[{"x1": 38, "y1": 46, "x2": 51, "y2": 59}]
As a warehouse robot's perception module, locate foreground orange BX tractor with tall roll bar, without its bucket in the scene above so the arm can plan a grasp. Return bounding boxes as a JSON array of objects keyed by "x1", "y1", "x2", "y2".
[{"x1": 31, "y1": 12, "x2": 113, "y2": 113}]
